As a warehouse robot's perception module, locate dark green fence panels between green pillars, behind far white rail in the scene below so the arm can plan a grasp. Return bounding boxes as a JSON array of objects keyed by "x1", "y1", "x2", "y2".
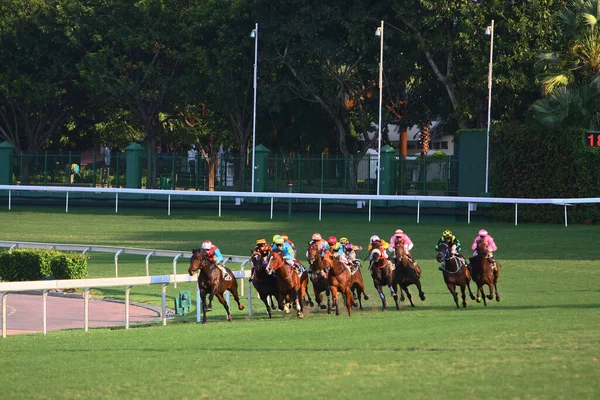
[{"x1": 13, "y1": 151, "x2": 458, "y2": 195}]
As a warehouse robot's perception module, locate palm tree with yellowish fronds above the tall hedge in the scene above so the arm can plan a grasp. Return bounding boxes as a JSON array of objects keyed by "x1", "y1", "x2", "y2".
[{"x1": 532, "y1": 0, "x2": 600, "y2": 129}]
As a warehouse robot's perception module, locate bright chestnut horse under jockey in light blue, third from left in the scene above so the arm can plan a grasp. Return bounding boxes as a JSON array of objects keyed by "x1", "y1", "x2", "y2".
[{"x1": 267, "y1": 249, "x2": 308, "y2": 318}]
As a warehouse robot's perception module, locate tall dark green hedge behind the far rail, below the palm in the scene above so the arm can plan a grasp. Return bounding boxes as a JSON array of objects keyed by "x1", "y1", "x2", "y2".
[{"x1": 490, "y1": 123, "x2": 600, "y2": 223}]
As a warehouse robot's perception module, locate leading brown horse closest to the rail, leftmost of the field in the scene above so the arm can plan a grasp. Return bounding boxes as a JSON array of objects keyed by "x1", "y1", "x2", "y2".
[{"x1": 188, "y1": 249, "x2": 244, "y2": 324}]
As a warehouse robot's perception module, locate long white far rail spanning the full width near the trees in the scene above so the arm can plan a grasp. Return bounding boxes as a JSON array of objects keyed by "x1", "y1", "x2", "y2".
[{"x1": 0, "y1": 185, "x2": 600, "y2": 226}]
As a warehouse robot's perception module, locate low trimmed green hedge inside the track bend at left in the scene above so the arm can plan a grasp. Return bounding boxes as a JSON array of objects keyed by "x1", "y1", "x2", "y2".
[{"x1": 0, "y1": 249, "x2": 88, "y2": 281}]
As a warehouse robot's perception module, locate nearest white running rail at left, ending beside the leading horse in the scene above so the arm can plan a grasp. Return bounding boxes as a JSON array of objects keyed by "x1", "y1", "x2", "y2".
[{"x1": 0, "y1": 271, "x2": 252, "y2": 338}]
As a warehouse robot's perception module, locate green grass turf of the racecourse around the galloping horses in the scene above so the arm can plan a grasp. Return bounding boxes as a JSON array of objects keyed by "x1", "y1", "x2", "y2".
[{"x1": 0, "y1": 207, "x2": 600, "y2": 399}]
